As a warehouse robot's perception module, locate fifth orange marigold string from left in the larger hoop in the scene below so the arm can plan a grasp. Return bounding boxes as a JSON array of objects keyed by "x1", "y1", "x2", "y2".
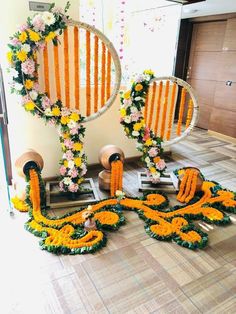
[{"x1": 86, "y1": 31, "x2": 91, "y2": 116}]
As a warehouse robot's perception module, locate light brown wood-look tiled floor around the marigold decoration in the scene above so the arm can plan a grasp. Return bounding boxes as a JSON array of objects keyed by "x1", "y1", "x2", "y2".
[{"x1": 0, "y1": 129, "x2": 236, "y2": 314}]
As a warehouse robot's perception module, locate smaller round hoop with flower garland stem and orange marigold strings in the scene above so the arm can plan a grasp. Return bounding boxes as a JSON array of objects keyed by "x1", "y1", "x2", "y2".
[{"x1": 120, "y1": 70, "x2": 198, "y2": 183}]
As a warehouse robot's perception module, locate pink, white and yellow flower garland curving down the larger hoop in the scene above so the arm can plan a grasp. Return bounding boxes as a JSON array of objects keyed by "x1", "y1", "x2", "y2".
[{"x1": 7, "y1": 2, "x2": 87, "y2": 192}]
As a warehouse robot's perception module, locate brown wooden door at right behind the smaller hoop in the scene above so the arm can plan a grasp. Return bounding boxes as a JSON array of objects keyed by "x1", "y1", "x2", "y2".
[{"x1": 188, "y1": 19, "x2": 236, "y2": 137}]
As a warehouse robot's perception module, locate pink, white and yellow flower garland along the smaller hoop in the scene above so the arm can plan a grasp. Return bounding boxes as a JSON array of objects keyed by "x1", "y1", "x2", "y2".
[{"x1": 120, "y1": 70, "x2": 166, "y2": 183}]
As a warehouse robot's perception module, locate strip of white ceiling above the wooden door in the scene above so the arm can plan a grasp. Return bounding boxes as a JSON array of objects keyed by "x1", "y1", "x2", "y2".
[{"x1": 182, "y1": 0, "x2": 236, "y2": 19}]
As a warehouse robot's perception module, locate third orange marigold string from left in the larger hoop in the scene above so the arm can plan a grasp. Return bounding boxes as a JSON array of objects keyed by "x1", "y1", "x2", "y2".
[{"x1": 63, "y1": 28, "x2": 70, "y2": 108}]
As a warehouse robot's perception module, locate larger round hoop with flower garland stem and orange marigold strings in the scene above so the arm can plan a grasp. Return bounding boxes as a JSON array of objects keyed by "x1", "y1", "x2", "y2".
[{"x1": 7, "y1": 3, "x2": 121, "y2": 192}]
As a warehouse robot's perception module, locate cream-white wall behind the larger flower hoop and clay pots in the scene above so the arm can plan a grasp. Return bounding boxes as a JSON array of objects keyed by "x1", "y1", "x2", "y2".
[{"x1": 0, "y1": 0, "x2": 181, "y2": 176}]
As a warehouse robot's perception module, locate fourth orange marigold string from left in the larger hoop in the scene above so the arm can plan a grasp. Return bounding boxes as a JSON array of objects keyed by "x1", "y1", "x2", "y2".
[{"x1": 74, "y1": 26, "x2": 80, "y2": 109}]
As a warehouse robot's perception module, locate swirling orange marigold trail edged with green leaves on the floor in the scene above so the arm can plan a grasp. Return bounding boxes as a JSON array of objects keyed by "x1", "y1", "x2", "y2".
[{"x1": 13, "y1": 169, "x2": 236, "y2": 254}]
